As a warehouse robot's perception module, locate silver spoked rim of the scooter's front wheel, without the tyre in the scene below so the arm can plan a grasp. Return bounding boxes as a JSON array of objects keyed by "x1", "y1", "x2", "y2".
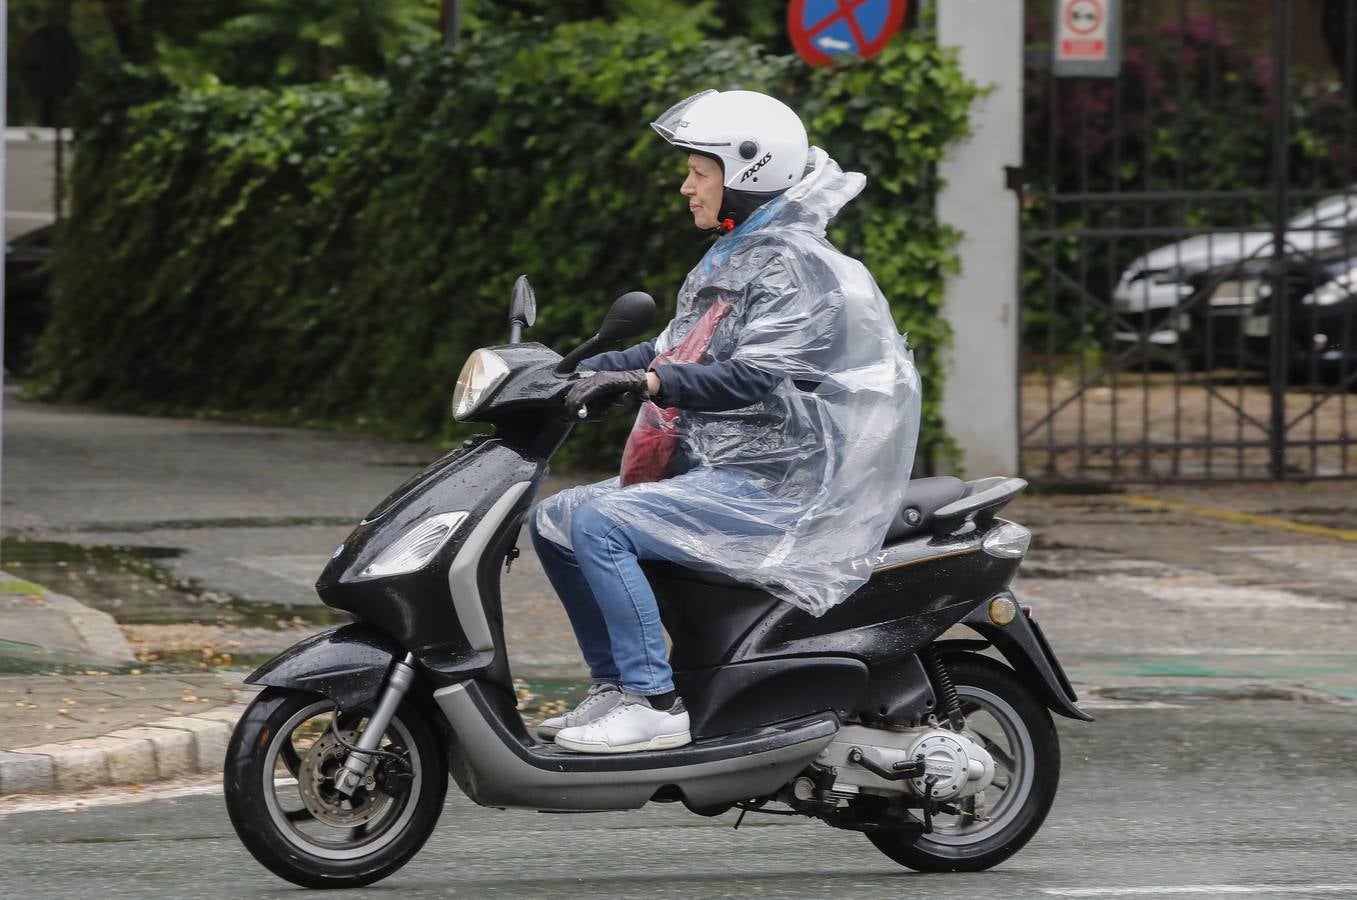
[{"x1": 262, "y1": 700, "x2": 423, "y2": 859}]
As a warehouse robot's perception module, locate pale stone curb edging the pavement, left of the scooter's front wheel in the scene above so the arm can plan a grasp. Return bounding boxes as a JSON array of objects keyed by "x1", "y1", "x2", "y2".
[{"x1": 0, "y1": 695, "x2": 251, "y2": 800}]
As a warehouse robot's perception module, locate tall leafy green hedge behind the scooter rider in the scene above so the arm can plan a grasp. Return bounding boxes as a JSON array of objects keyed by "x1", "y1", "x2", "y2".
[{"x1": 31, "y1": 16, "x2": 976, "y2": 468}]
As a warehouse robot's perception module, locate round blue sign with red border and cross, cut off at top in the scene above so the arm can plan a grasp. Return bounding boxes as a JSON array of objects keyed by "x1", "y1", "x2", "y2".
[{"x1": 787, "y1": 0, "x2": 909, "y2": 65}]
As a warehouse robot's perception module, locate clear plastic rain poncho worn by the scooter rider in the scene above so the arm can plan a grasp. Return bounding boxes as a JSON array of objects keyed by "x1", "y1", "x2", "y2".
[{"x1": 536, "y1": 147, "x2": 920, "y2": 615}]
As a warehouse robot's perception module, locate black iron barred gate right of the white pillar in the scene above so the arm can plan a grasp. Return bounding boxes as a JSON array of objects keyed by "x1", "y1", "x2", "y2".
[{"x1": 1019, "y1": 0, "x2": 1357, "y2": 482}]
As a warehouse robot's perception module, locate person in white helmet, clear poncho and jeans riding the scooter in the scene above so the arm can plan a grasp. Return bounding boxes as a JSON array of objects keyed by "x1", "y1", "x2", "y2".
[{"x1": 531, "y1": 91, "x2": 919, "y2": 753}]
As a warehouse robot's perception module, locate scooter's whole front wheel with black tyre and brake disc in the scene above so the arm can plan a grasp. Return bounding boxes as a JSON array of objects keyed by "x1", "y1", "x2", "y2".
[{"x1": 224, "y1": 688, "x2": 448, "y2": 888}]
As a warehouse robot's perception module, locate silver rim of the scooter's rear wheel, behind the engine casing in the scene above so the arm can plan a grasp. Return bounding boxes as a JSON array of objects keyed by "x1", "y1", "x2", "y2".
[{"x1": 921, "y1": 684, "x2": 1035, "y2": 847}]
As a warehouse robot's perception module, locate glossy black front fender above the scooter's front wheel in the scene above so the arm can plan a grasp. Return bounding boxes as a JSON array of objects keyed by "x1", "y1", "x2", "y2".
[{"x1": 246, "y1": 624, "x2": 404, "y2": 710}]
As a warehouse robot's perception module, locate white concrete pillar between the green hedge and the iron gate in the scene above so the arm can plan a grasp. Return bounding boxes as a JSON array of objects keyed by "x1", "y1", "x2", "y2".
[{"x1": 936, "y1": 0, "x2": 1023, "y2": 478}]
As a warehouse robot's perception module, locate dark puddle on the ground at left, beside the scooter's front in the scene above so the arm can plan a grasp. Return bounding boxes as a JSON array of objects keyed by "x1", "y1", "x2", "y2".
[{"x1": 0, "y1": 538, "x2": 339, "y2": 629}]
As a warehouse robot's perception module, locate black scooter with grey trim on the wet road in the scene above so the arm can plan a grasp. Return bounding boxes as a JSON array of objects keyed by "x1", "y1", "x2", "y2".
[{"x1": 224, "y1": 278, "x2": 1091, "y2": 888}]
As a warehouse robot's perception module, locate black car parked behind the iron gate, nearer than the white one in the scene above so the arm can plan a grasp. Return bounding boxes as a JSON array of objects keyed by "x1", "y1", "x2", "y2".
[{"x1": 1174, "y1": 243, "x2": 1357, "y2": 377}]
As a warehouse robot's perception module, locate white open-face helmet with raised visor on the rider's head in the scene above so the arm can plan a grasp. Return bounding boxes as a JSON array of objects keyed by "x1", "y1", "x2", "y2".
[{"x1": 650, "y1": 91, "x2": 809, "y2": 229}]
